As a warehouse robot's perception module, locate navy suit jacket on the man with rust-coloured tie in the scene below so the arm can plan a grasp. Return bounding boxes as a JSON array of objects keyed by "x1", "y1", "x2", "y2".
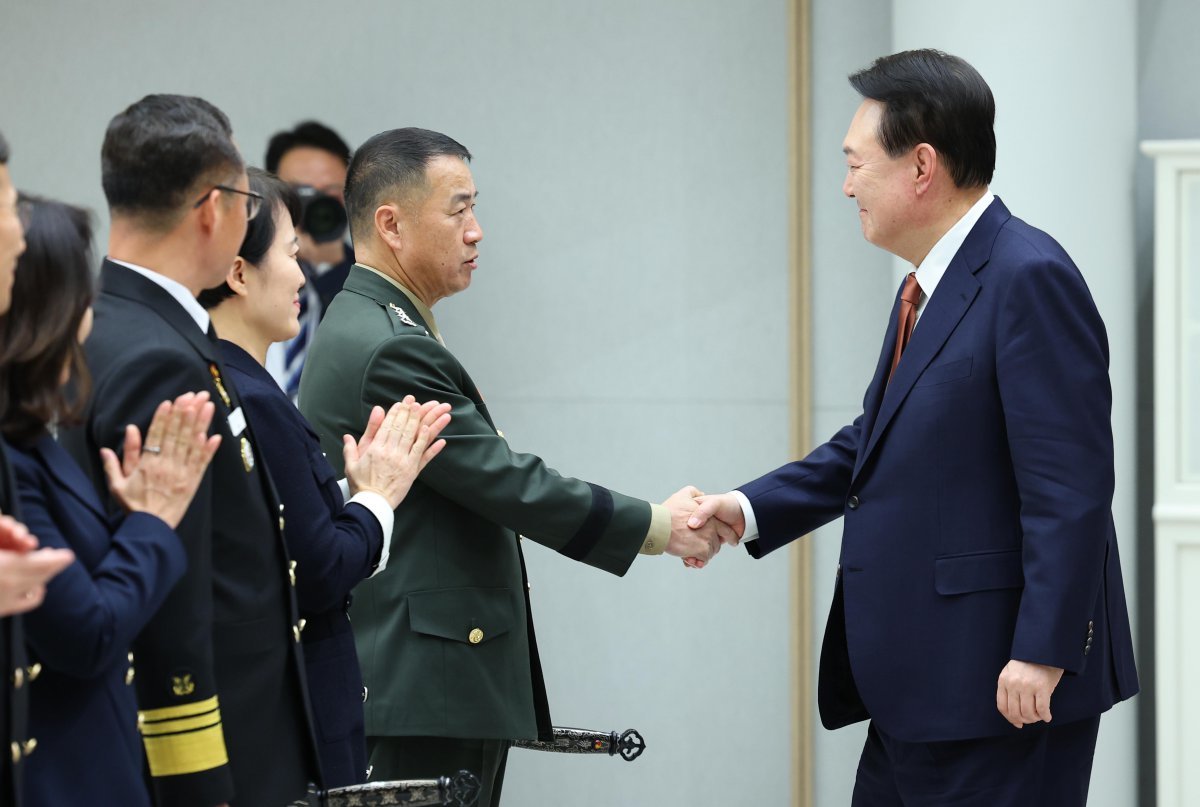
[{"x1": 739, "y1": 199, "x2": 1138, "y2": 741}]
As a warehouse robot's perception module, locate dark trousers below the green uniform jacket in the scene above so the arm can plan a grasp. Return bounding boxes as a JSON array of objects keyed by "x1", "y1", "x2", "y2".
[{"x1": 367, "y1": 737, "x2": 512, "y2": 807}]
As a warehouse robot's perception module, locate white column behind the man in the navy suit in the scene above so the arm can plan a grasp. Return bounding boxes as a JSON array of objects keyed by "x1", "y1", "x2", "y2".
[{"x1": 889, "y1": 0, "x2": 1138, "y2": 807}]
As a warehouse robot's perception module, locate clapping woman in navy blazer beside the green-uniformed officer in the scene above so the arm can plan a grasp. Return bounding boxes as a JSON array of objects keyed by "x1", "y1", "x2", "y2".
[{"x1": 199, "y1": 168, "x2": 450, "y2": 788}]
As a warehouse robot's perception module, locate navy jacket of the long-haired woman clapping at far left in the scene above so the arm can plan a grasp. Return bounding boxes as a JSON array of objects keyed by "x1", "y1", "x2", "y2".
[{"x1": 11, "y1": 435, "x2": 187, "y2": 806}]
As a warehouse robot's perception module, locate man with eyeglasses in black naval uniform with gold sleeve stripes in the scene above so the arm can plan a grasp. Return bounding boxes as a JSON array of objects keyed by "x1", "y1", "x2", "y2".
[{"x1": 64, "y1": 95, "x2": 317, "y2": 807}]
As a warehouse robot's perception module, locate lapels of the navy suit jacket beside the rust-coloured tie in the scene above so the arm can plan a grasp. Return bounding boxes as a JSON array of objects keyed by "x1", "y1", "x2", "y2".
[{"x1": 854, "y1": 197, "x2": 1012, "y2": 477}]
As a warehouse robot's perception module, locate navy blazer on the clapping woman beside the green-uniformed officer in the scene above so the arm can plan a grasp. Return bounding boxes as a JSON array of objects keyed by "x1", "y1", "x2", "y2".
[{"x1": 220, "y1": 340, "x2": 383, "y2": 788}]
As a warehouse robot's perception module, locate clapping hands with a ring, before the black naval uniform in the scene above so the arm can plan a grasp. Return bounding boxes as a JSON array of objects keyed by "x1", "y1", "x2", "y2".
[{"x1": 100, "y1": 393, "x2": 221, "y2": 530}]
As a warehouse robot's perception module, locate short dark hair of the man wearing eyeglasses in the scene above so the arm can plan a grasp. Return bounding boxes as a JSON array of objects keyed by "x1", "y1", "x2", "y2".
[{"x1": 100, "y1": 95, "x2": 245, "y2": 227}]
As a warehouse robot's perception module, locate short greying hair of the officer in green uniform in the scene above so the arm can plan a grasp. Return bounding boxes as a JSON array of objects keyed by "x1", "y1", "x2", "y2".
[{"x1": 346, "y1": 127, "x2": 470, "y2": 241}]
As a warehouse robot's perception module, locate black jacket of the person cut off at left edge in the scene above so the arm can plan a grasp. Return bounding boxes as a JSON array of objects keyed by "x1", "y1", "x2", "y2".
[{"x1": 0, "y1": 440, "x2": 29, "y2": 807}]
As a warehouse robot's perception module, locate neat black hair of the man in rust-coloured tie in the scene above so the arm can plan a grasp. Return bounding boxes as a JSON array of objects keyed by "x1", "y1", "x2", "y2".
[{"x1": 850, "y1": 49, "x2": 996, "y2": 189}]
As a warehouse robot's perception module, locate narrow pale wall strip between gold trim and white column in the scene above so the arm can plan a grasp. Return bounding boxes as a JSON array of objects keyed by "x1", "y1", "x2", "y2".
[{"x1": 809, "y1": 0, "x2": 895, "y2": 807}]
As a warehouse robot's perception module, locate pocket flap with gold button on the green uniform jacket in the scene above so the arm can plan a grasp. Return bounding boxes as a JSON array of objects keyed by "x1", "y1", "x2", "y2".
[{"x1": 408, "y1": 588, "x2": 512, "y2": 645}]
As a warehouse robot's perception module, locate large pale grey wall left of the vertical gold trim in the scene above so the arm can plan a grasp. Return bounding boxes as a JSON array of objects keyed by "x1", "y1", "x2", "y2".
[{"x1": 0, "y1": 0, "x2": 792, "y2": 807}]
